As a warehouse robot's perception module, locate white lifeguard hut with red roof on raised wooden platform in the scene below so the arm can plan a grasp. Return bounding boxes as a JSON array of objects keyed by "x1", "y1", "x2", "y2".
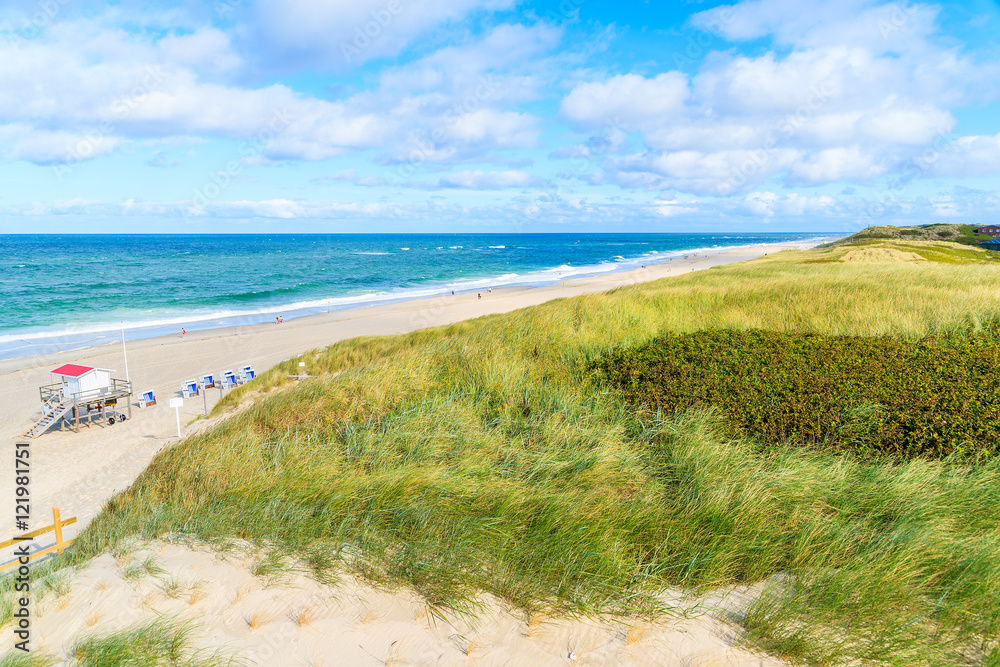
[{"x1": 21, "y1": 364, "x2": 132, "y2": 438}]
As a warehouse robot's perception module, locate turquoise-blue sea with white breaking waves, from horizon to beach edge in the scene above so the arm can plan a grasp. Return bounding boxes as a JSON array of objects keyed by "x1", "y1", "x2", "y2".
[{"x1": 0, "y1": 233, "x2": 819, "y2": 359}]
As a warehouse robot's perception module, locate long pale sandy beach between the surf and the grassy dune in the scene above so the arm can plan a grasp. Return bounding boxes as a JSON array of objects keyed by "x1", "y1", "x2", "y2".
[{"x1": 0, "y1": 240, "x2": 822, "y2": 538}]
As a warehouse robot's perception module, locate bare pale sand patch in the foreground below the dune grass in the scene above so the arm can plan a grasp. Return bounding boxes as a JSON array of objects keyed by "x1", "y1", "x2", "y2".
[{"x1": 35, "y1": 542, "x2": 783, "y2": 667}]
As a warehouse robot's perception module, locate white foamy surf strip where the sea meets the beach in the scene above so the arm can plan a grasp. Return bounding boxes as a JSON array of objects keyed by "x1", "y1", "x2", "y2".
[{"x1": 0, "y1": 236, "x2": 828, "y2": 363}]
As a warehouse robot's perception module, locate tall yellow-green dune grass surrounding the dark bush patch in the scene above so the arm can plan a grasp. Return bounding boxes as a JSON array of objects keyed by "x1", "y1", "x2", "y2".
[{"x1": 19, "y1": 241, "x2": 1000, "y2": 665}]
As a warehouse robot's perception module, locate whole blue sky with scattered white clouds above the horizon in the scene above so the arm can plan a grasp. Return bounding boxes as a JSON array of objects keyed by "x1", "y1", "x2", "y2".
[{"x1": 0, "y1": 0, "x2": 1000, "y2": 233}]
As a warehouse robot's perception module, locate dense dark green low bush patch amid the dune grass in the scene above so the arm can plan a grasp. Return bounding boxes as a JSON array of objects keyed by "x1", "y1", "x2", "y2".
[{"x1": 590, "y1": 324, "x2": 1000, "y2": 458}]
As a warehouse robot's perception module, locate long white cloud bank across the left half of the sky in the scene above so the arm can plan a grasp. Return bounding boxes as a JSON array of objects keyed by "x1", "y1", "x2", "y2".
[{"x1": 0, "y1": 13, "x2": 548, "y2": 164}]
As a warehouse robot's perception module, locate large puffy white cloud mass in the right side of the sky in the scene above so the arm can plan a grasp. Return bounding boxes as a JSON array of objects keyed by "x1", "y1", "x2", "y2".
[{"x1": 553, "y1": 0, "x2": 995, "y2": 195}]
